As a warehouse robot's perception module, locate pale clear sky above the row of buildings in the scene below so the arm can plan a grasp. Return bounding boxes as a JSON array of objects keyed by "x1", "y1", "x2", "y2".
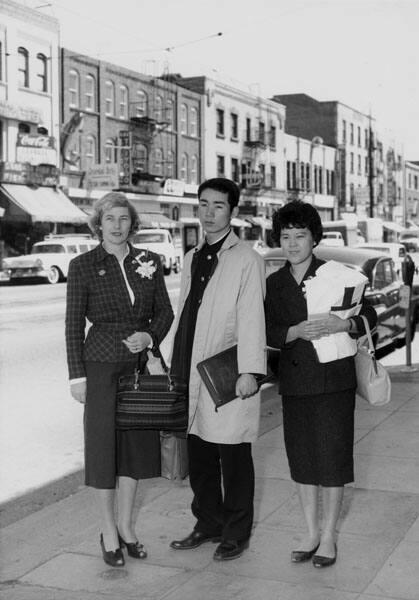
[{"x1": 21, "y1": 0, "x2": 419, "y2": 160}]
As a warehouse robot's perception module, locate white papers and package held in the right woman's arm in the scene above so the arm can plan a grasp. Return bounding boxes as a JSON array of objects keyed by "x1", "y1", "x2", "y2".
[{"x1": 304, "y1": 260, "x2": 368, "y2": 363}]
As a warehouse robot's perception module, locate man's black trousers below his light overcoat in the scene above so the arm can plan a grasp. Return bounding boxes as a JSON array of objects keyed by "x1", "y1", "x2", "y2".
[{"x1": 188, "y1": 435, "x2": 255, "y2": 541}]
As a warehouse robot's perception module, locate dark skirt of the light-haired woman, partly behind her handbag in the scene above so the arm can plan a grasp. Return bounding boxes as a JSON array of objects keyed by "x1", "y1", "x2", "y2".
[{"x1": 84, "y1": 362, "x2": 161, "y2": 489}]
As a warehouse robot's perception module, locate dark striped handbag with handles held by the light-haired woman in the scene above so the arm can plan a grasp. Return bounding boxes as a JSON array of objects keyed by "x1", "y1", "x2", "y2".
[{"x1": 115, "y1": 350, "x2": 188, "y2": 431}]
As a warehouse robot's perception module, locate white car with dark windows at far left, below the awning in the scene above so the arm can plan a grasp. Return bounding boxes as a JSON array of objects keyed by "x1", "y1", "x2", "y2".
[{"x1": 3, "y1": 234, "x2": 98, "y2": 284}]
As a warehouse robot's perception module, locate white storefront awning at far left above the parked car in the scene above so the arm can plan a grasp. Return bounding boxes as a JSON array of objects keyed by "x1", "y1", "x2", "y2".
[{"x1": 1, "y1": 183, "x2": 87, "y2": 225}]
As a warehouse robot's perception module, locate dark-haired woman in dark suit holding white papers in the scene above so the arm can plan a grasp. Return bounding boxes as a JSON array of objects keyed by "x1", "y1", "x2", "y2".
[{"x1": 266, "y1": 201, "x2": 377, "y2": 567}]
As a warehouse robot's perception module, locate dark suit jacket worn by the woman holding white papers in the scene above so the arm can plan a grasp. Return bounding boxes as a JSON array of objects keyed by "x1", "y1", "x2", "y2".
[{"x1": 265, "y1": 256, "x2": 377, "y2": 396}]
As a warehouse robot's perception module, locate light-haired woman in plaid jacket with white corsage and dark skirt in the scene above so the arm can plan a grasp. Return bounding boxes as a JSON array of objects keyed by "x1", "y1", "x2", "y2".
[{"x1": 66, "y1": 192, "x2": 173, "y2": 566}]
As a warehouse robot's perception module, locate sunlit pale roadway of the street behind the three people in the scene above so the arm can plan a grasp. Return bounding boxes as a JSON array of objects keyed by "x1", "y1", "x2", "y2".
[{"x1": 0, "y1": 274, "x2": 419, "y2": 503}]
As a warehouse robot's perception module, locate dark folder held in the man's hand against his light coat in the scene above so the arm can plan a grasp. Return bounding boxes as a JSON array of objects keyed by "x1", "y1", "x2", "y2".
[{"x1": 196, "y1": 344, "x2": 272, "y2": 410}]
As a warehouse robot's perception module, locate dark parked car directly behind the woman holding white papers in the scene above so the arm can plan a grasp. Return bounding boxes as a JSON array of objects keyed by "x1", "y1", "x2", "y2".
[{"x1": 264, "y1": 245, "x2": 419, "y2": 355}]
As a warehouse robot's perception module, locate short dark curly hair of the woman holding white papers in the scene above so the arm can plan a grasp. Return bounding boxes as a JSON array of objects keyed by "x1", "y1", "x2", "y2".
[{"x1": 271, "y1": 200, "x2": 323, "y2": 246}]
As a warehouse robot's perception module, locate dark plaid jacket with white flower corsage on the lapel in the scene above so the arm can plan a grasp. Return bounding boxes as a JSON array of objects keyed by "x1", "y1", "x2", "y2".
[{"x1": 65, "y1": 244, "x2": 173, "y2": 379}]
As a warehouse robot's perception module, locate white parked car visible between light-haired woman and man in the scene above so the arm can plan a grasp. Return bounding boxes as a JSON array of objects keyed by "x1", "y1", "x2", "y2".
[{"x1": 132, "y1": 229, "x2": 183, "y2": 275}]
